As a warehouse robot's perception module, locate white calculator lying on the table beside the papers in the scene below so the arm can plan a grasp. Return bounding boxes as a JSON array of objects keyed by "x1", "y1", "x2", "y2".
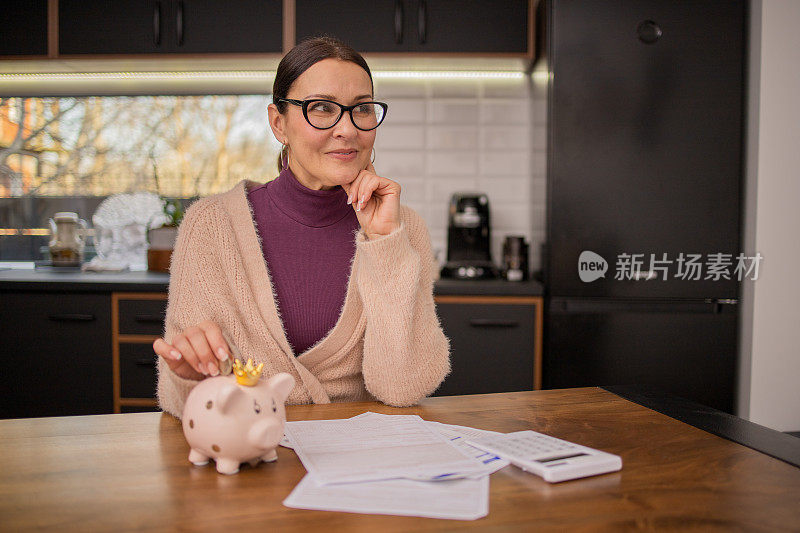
[{"x1": 466, "y1": 431, "x2": 622, "y2": 483}]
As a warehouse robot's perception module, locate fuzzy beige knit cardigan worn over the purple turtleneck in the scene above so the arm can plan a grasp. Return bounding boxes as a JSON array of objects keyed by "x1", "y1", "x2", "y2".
[{"x1": 158, "y1": 180, "x2": 450, "y2": 417}]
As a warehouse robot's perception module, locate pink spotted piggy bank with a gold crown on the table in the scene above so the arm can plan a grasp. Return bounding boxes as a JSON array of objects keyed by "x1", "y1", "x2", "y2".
[{"x1": 182, "y1": 360, "x2": 294, "y2": 474}]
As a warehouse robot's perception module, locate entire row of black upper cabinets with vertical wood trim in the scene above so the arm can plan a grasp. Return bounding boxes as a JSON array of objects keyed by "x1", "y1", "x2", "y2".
[{"x1": 0, "y1": 0, "x2": 537, "y2": 59}]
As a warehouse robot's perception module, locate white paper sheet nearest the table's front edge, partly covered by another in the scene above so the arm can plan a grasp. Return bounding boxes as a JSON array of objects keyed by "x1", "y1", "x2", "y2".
[{"x1": 283, "y1": 474, "x2": 489, "y2": 520}]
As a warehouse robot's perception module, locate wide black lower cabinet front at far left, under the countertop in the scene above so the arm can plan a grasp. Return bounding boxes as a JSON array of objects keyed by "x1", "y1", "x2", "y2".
[{"x1": 0, "y1": 292, "x2": 113, "y2": 418}]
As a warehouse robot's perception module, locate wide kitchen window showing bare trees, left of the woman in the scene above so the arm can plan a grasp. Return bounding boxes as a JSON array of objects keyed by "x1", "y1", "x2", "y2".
[{"x1": 0, "y1": 95, "x2": 280, "y2": 261}]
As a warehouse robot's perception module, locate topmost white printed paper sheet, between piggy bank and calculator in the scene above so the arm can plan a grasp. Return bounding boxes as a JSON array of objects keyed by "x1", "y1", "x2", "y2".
[{"x1": 285, "y1": 413, "x2": 487, "y2": 484}]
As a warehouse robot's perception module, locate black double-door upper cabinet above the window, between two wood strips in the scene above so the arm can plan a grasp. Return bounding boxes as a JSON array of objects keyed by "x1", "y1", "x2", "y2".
[{"x1": 58, "y1": 0, "x2": 283, "y2": 56}]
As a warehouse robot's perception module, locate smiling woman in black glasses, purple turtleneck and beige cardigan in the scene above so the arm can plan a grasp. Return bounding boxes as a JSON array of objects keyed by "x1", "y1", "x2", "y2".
[{"x1": 153, "y1": 38, "x2": 450, "y2": 417}]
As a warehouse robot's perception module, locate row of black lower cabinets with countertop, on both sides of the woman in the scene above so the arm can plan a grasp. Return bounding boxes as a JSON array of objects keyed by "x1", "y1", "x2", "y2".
[{"x1": 0, "y1": 270, "x2": 543, "y2": 418}]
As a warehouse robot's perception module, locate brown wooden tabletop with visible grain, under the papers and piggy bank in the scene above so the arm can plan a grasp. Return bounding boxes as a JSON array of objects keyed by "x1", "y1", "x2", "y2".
[{"x1": 0, "y1": 388, "x2": 800, "y2": 532}]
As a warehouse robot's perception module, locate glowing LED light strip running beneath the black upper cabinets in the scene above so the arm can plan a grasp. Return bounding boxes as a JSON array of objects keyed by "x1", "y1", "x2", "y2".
[{"x1": 0, "y1": 70, "x2": 526, "y2": 82}]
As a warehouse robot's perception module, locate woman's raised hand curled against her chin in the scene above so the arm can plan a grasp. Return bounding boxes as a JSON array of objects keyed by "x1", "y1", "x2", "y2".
[{"x1": 342, "y1": 163, "x2": 400, "y2": 239}]
